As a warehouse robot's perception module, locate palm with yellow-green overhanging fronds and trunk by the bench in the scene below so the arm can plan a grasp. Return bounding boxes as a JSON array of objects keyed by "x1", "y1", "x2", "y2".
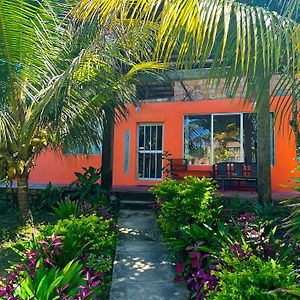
[{"x1": 77, "y1": 0, "x2": 300, "y2": 203}]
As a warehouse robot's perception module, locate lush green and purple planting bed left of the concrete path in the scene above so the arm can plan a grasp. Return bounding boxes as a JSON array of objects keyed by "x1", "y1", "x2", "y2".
[{"x1": 0, "y1": 176, "x2": 116, "y2": 300}]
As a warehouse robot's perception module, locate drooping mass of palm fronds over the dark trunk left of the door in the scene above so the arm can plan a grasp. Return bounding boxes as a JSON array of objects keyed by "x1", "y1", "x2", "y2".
[{"x1": 23, "y1": 14, "x2": 167, "y2": 155}]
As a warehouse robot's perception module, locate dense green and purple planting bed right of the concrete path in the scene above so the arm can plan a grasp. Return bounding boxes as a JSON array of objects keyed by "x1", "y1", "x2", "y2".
[{"x1": 152, "y1": 177, "x2": 299, "y2": 300}]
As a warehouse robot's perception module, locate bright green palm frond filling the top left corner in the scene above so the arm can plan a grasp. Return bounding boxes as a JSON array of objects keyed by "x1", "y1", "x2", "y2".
[{"x1": 0, "y1": 0, "x2": 59, "y2": 88}]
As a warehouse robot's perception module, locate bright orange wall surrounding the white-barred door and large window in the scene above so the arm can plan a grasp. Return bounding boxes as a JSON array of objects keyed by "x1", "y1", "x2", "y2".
[{"x1": 114, "y1": 99, "x2": 296, "y2": 191}]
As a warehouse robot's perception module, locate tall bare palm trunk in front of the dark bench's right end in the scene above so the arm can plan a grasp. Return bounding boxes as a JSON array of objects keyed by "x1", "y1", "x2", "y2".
[{"x1": 257, "y1": 79, "x2": 272, "y2": 205}]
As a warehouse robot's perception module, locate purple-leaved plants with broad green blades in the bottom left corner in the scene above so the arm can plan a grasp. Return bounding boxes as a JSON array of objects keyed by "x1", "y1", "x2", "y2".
[{"x1": 0, "y1": 235, "x2": 103, "y2": 300}]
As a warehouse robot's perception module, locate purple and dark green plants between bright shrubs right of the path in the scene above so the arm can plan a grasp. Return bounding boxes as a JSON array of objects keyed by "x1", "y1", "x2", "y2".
[{"x1": 172, "y1": 213, "x2": 296, "y2": 300}]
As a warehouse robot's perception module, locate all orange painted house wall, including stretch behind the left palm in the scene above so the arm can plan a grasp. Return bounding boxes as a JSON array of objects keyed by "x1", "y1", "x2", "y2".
[{"x1": 30, "y1": 99, "x2": 300, "y2": 191}]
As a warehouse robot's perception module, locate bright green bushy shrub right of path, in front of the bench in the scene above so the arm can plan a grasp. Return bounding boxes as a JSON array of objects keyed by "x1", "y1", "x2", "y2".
[{"x1": 151, "y1": 176, "x2": 221, "y2": 237}]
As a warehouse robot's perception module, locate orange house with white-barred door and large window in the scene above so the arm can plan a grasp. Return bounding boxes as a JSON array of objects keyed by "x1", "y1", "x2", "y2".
[{"x1": 30, "y1": 79, "x2": 297, "y2": 191}]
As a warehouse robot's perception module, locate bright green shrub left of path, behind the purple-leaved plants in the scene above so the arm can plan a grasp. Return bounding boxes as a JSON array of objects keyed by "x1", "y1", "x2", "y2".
[{"x1": 39, "y1": 215, "x2": 116, "y2": 265}]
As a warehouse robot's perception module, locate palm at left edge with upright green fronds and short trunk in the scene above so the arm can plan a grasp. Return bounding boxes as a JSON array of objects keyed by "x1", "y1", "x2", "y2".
[{"x1": 0, "y1": 0, "x2": 64, "y2": 217}]
